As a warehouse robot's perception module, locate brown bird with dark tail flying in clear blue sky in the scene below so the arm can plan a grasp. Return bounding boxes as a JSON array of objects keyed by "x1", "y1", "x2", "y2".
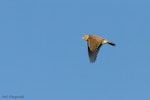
[{"x1": 82, "y1": 35, "x2": 115, "y2": 63}]
